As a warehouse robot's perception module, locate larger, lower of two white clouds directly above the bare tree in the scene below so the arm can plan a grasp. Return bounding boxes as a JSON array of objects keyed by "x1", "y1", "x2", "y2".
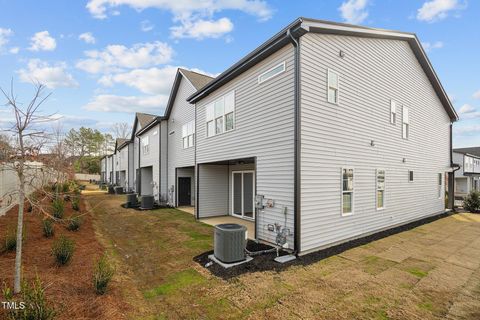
[{"x1": 18, "y1": 59, "x2": 78, "y2": 89}]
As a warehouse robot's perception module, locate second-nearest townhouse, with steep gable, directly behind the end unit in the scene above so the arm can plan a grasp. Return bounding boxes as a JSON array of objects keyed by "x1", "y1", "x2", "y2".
[{"x1": 163, "y1": 69, "x2": 213, "y2": 207}]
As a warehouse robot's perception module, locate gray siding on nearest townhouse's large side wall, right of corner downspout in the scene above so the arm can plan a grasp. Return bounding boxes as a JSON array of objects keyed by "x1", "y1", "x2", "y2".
[{"x1": 300, "y1": 33, "x2": 450, "y2": 252}]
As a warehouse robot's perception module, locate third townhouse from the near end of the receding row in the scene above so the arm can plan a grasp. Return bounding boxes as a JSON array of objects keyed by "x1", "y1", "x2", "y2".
[{"x1": 129, "y1": 112, "x2": 157, "y2": 195}]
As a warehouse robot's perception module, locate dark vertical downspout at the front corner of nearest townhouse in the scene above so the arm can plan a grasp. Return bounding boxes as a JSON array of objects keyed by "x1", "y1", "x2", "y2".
[{"x1": 287, "y1": 29, "x2": 300, "y2": 254}]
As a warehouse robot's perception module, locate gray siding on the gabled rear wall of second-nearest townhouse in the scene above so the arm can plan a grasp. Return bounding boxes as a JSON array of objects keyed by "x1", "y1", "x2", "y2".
[{"x1": 168, "y1": 77, "x2": 195, "y2": 206}]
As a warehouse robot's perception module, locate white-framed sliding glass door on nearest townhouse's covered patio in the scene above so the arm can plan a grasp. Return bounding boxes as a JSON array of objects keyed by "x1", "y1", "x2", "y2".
[{"x1": 232, "y1": 170, "x2": 255, "y2": 219}]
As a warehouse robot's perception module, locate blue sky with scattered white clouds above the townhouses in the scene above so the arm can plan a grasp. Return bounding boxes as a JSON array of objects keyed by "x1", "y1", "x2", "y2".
[{"x1": 0, "y1": 0, "x2": 480, "y2": 147}]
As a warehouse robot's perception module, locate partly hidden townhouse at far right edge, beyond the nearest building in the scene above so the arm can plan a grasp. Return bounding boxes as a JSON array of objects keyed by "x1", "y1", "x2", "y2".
[{"x1": 453, "y1": 147, "x2": 480, "y2": 198}]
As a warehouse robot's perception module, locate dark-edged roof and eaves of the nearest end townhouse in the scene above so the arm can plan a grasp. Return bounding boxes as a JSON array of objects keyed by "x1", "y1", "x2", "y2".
[{"x1": 187, "y1": 17, "x2": 458, "y2": 121}]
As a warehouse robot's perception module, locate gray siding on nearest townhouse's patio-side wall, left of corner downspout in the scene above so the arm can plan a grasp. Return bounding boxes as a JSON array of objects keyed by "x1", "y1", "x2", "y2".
[{"x1": 196, "y1": 45, "x2": 294, "y2": 247}]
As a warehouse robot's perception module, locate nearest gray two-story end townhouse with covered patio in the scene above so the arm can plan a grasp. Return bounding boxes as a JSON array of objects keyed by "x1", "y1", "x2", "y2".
[{"x1": 187, "y1": 18, "x2": 458, "y2": 253}]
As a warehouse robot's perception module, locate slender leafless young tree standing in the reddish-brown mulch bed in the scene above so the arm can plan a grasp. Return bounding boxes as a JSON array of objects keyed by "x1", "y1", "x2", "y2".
[{"x1": 0, "y1": 80, "x2": 52, "y2": 293}]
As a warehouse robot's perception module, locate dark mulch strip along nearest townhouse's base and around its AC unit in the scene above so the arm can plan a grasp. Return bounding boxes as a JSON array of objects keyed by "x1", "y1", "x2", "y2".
[{"x1": 193, "y1": 213, "x2": 451, "y2": 280}]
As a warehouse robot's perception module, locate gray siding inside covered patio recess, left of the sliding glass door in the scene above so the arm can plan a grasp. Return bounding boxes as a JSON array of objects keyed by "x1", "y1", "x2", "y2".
[{"x1": 198, "y1": 164, "x2": 229, "y2": 218}]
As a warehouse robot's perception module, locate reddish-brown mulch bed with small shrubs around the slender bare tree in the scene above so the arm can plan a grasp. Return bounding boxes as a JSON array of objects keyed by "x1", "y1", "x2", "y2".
[{"x1": 0, "y1": 199, "x2": 128, "y2": 320}]
